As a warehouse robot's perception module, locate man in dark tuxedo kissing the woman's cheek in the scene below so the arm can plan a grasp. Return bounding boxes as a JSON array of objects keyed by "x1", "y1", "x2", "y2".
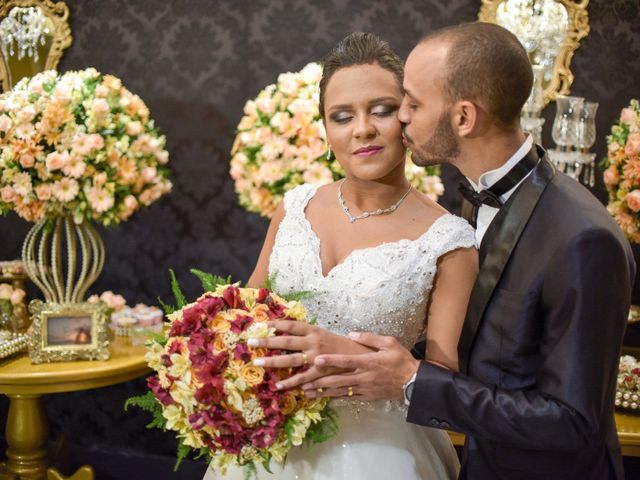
[{"x1": 252, "y1": 23, "x2": 635, "y2": 480}]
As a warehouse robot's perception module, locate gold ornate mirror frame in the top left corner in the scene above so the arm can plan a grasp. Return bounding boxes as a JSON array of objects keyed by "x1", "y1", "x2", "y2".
[{"x1": 0, "y1": 0, "x2": 72, "y2": 92}]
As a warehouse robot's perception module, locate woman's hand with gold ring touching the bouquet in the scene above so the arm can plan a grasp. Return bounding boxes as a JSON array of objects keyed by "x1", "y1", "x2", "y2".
[{"x1": 247, "y1": 320, "x2": 372, "y2": 389}]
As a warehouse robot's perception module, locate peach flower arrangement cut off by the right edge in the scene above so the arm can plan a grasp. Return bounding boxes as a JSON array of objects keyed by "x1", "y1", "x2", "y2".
[{"x1": 601, "y1": 100, "x2": 640, "y2": 243}]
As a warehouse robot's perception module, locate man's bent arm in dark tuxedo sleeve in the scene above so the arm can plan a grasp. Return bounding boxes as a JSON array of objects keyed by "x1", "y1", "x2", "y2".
[{"x1": 407, "y1": 231, "x2": 633, "y2": 450}]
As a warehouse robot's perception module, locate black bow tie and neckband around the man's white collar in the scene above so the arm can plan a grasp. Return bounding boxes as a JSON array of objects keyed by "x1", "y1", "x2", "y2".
[{"x1": 458, "y1": 145, "x2": 539, "y2": 226}]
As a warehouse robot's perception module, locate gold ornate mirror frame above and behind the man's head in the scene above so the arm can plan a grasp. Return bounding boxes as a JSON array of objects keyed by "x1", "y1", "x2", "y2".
[{"x1": 478, "y1": 0, "x2": 589, "y2": 105}]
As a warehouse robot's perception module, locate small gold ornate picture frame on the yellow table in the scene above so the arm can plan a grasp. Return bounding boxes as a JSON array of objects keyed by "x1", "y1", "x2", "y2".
[{"x1": 29, "y1": 300, "x2": 109, "y2": 363}]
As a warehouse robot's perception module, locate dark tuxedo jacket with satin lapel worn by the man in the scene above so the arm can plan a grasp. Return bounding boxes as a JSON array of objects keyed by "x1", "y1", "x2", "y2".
[{"x1": 407, "y1": 154, "x2": 635, "y2": 480}]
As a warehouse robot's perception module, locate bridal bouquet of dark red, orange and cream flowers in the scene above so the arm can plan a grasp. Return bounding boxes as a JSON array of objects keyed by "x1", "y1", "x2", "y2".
[{"x1": 125, "y1": 270, "x2": 337, "y2": 474}]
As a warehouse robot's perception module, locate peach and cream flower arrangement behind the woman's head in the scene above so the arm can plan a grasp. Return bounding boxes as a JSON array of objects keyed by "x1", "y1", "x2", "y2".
[{"x1": 231, "y1": 63, "x2": 444, "y2": 217}]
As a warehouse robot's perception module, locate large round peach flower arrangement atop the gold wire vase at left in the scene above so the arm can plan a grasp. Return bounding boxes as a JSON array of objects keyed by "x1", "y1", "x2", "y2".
[{"x1": 0, "y1": 68, "x2": 171, "y2": 226}]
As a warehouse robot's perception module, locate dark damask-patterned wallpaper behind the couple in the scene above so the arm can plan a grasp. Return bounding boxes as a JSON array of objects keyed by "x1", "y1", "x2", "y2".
[{"x1": 0, "y1": 0, "x2": 640, "y2": 479}]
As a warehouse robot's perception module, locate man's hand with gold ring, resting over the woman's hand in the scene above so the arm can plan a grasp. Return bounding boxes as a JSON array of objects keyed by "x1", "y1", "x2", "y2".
[{"x1": 302, "y1": 332, "x2": 420, "y2": 400}]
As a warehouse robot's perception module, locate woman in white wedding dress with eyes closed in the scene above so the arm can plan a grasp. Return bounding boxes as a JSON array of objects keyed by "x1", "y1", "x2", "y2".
[{"x1": 205, "y1": 33, "x2": 477, "y2": 480}]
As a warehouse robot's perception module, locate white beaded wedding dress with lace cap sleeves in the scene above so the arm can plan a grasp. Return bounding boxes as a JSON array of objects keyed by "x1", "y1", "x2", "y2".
[{"x1": 204, "y1": 184, "x2": 475, "y2": 480}]
